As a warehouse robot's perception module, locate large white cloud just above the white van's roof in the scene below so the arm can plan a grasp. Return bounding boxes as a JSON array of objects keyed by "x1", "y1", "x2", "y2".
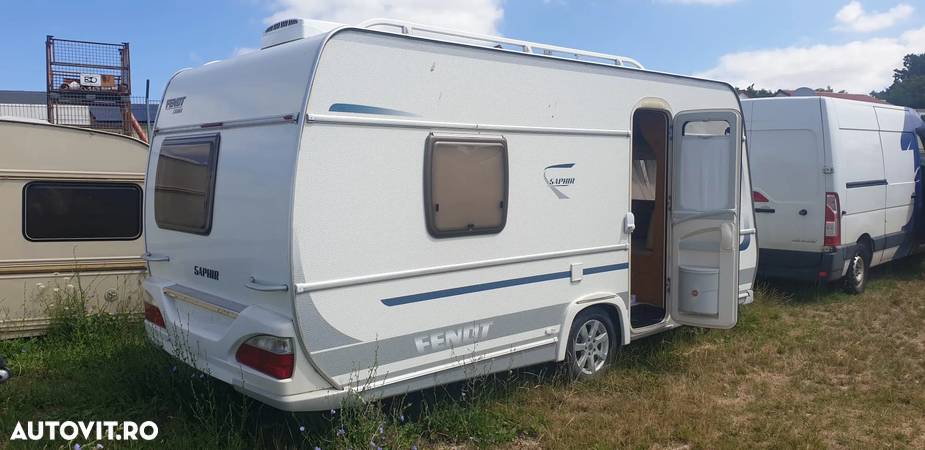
[{"x1": 696, "y1": 27, "x2": 925, "y2": 93}]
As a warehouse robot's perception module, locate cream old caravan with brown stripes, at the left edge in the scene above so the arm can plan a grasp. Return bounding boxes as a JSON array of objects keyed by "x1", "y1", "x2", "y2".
[{"x1": 0, "y1": 118, "x2": 148, "y2": 338}]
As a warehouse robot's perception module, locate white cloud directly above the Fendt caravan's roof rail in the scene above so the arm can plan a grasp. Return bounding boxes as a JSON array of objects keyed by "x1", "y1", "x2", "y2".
[{"x1": 265, "y1": 0, "x2": 504, "y2": 34}]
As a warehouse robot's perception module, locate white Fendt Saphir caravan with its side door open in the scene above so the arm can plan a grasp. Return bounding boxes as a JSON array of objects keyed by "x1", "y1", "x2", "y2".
[{"x1": 145, "y1": 20, "x2": 756, "y2": 410}]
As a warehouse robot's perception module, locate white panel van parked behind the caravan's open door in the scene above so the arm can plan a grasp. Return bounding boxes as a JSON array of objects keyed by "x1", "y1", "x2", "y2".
[{"x1": 742, "y1": 97, "x2": 925, "y2": 293}]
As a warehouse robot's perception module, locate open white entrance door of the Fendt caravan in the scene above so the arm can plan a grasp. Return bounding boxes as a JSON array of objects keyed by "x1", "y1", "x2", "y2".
[{"x1": 668, "y1": 110, "x2": 742, "y2": 328}]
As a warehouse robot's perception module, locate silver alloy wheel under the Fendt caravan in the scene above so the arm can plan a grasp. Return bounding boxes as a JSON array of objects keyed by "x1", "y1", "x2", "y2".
[{"x1": 566, "y1": 308, "x2": 618, "y2": 379}]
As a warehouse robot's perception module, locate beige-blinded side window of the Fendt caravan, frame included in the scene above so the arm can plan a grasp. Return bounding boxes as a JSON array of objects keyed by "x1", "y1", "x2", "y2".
[{"x1": 424, "y1": 135, "x2": 508, "y2": 237}]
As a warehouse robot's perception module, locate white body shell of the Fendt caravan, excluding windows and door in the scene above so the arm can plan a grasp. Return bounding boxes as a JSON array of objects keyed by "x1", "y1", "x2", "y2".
[{"x1": 146, "y1": 28, "x2": 757, "y2": 409}]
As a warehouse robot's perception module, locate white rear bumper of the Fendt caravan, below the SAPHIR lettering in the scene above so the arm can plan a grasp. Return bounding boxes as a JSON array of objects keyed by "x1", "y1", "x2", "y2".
[{"x1": 144, "y1": 278, "x2": 347, "y2": 411}]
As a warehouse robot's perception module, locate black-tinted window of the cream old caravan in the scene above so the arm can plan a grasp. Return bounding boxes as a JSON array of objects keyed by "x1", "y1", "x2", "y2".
[{"x1": 23, "y1": 181, "x2": 142, "y2": 241}]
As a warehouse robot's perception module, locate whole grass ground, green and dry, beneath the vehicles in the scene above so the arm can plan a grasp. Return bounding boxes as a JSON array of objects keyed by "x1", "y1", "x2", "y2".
[{"x1": 0, "y1": 260, "x2": 925, "y2": 449}]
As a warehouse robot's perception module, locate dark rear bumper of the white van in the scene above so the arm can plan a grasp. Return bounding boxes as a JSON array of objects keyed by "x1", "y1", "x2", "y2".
[{"x1": 758, "y1": 244, "x2": 855, "y2": 281}]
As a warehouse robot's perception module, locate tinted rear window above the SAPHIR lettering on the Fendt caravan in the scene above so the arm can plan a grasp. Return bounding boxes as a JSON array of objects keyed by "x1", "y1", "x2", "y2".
[{"x1": 154, "y1": 134, "x2": 219, "y2": 234}]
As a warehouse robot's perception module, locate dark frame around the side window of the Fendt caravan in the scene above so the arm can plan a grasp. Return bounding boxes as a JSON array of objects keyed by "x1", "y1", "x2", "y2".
[{"x1": 424, "y1": 133, "x2": 511, "y2": 239}]
